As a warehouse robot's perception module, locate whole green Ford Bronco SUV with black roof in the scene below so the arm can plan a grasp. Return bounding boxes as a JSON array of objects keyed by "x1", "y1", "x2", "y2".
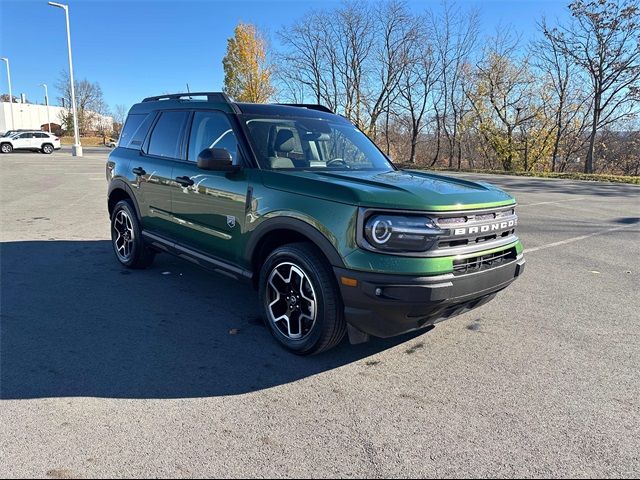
[{"x1": 107, "y1": 93, "x2": 524, "y2": 354}]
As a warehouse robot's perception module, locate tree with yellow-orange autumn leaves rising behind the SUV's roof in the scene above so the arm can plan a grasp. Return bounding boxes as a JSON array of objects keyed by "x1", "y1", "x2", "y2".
[{"x1": 222, "y1": 23, "x2": 274, "y2": 103}]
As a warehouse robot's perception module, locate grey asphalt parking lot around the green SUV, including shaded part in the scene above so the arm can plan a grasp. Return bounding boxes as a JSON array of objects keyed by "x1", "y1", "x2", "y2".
[{"x1": 0, "y1": 149, "x2": 640, "y2": 478}]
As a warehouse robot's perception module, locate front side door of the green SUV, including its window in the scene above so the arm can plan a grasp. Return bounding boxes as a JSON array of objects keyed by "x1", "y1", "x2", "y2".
[{"x1": 172, "y1": 110, "x2": 248, "y2": 263}]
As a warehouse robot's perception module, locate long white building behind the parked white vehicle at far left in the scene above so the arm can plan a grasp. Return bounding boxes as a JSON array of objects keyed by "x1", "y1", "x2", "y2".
[{"x1": 0, "y1": 102, "x2": 113, "y2": 132}]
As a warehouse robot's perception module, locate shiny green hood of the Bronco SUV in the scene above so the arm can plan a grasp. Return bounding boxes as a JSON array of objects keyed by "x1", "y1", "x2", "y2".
[{"x1": 263, "y1": 170, "x2": 515, "y2": 211}]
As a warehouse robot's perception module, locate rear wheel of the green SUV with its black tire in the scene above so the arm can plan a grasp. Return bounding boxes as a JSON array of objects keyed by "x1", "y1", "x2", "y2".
[{"x1": 111, "y1": 200, "x2": 155, "y2": 269}]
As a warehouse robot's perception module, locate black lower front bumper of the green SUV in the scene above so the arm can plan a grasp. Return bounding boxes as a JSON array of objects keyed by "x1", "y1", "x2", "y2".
[{"x1": 334, "y1": 255, "x2": 525, "y2": 342}]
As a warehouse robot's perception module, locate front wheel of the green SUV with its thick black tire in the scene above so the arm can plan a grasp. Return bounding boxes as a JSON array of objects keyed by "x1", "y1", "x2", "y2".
[{"x1": 259, "y1": 243, "x2": 347, "y2": 355}]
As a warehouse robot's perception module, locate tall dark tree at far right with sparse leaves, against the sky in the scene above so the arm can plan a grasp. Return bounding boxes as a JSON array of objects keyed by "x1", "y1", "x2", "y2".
[{"x1": 544, "y1": 0, "x2": 640, "y2": 173}]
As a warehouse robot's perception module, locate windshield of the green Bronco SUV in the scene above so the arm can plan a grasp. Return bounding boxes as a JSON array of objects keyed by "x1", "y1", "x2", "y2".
[{"x1": 242, "y1": 115, "x2": 394, "y2": 171}]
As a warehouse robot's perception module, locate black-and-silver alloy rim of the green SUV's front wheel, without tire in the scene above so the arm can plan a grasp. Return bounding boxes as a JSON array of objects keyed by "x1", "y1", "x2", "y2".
[{"x1": 266, "y1": 262, "x2": 317, "y2": 340}]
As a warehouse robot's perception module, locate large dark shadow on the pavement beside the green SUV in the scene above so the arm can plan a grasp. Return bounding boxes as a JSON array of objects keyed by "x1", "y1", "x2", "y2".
[{"x1": 0, "y1": 241, "x2": 428, "y2": 399}]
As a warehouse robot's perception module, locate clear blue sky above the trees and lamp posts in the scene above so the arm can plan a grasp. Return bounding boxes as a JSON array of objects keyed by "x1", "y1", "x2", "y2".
[{"x1": 0, "y1": 0, "x2": 568, "y2": 111}]
